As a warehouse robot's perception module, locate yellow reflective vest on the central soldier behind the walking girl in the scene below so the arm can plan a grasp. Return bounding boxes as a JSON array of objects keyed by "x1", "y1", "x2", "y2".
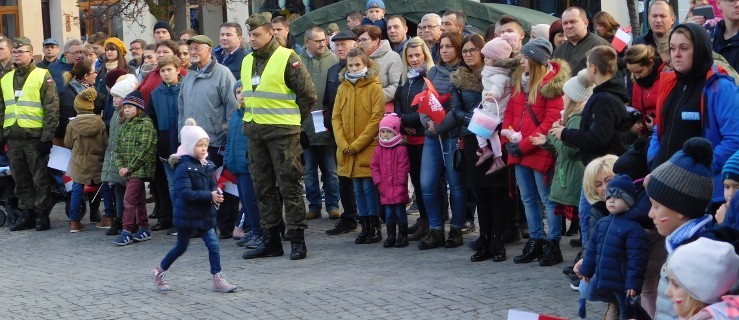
[{"x1": 241, "y1": 47, "x2": 300, "y2": 126}]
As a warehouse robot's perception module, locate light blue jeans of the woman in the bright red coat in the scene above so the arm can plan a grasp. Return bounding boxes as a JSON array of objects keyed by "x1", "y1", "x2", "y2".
[{"x1": 516, "y1": 164, "x2": 562, "y2": 241}]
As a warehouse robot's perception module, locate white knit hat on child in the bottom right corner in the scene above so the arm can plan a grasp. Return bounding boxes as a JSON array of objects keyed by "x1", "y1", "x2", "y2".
[{"x1": 667, "y1": 238, "x2": 739, "y2": 304}]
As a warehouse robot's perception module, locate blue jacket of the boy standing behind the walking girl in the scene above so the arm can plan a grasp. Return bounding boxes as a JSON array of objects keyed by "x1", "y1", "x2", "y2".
[{"x1": 146, "y1": 80, "x2": 182, "y2": 159}]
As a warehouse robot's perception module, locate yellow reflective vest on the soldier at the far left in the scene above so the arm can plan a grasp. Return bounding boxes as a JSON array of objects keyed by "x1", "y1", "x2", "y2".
[{"x1": 0, "y1": 68, "x2": 48, "y2": 129}]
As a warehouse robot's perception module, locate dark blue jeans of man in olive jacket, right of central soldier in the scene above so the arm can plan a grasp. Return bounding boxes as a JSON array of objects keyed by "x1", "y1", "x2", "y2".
[{"x1": 303, "y1": 145, "x2": 339, "y2": 212}]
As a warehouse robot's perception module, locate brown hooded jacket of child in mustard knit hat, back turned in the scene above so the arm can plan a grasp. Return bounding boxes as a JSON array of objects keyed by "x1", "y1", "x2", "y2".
[{"x1": 64, "y1": 114, "x2": 108, "y2": 184}]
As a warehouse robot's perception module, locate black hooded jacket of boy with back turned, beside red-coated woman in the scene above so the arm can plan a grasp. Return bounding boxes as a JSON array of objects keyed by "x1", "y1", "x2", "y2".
[{"x1": 561, "y1": 77, "x2": 631, "y2": 165}]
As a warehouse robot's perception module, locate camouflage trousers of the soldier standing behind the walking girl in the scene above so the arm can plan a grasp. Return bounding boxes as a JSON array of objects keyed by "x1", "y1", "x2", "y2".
[{"x1": 244, "y1": 123, "x2": 308, "y2": 229}]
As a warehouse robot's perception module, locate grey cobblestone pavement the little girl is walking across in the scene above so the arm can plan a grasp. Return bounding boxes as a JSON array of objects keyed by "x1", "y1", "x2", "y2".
[{"x1": 0, "y1": 203, "x2": 604, "y2": 319}]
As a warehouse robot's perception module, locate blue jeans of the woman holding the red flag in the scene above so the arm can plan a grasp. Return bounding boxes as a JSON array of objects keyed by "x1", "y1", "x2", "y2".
[{"x1": 421, "y1": 138, "x2": 467, "y2": 229}]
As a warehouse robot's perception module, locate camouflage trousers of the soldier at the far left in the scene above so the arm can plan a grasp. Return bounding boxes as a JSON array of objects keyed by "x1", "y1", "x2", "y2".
[{"x1": 8, "y1": 139, "x2": 54, "y2": 212}]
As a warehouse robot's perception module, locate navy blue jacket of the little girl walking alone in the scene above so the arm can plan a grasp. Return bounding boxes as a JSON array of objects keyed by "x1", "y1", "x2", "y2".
[{"x1": 170, "y1": 156, "x2": 216, "y2": 230}]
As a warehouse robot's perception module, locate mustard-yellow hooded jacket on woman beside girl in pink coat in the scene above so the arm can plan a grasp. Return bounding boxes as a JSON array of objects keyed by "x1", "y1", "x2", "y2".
[{"x1": 331, "y1": 62, "x2": 385, "y2": 178}]
